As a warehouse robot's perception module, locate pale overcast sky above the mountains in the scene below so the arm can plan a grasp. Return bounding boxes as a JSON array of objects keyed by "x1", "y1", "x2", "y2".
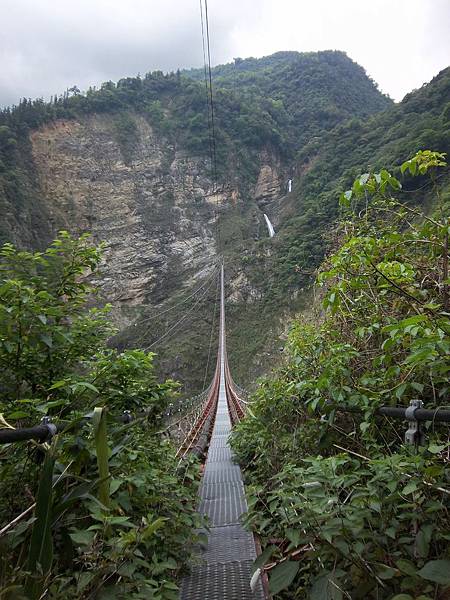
[{"x1": 0, "y1": 0, "x2": 450, "y2": 105}]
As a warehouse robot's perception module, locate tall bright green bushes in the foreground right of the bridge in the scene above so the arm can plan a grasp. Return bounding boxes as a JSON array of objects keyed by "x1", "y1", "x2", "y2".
[{"x1": 233, "y1": 151, "x2": 450, "y2": 600}]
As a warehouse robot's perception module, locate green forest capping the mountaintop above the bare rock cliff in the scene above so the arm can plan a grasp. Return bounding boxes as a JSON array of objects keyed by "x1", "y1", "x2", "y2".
[{"x1": 0, "y1": 52, "x2": 391, "y2": 246}]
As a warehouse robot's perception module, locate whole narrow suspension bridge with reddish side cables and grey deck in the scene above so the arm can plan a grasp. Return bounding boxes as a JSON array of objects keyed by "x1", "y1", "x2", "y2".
[{"x1": 172, "y1": 264, "x2": 266, "y2": 600}]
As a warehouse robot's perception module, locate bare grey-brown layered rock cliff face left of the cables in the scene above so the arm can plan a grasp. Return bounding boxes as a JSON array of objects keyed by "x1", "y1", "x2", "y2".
[{"x1": 32, "y1": 116, "x2": 222, "y2": 312}]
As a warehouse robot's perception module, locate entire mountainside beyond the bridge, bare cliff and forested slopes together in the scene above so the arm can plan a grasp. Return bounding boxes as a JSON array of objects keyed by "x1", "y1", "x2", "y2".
[{"x1": 0, "y1": 52, "x2": 448, "y2": 388}]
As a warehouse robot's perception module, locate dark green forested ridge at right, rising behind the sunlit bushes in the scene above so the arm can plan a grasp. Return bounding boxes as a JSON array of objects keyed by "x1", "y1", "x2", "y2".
[{"x1": 256, "y1": 68, "x2": 450, "y2": 290}]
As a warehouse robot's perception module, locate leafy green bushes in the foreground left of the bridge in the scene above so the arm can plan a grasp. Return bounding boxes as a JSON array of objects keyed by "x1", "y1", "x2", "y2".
[{"x1": 0, "y1": 232, "x2": 200, "y2": 600}]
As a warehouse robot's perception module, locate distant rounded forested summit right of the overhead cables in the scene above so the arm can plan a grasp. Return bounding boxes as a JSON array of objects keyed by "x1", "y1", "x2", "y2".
[{"x1": 186, "y1": 50, "x2": 393, "y2": 149}]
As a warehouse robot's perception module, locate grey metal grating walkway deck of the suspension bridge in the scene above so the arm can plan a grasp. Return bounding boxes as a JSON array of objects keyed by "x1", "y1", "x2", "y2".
[{"x1": 180, "y1": 357, "x2": 265, "y2": 600}]
